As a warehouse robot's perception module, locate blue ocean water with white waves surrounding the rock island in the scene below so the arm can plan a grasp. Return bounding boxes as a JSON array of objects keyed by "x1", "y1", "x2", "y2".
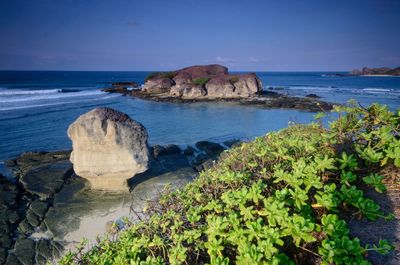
[{"x1": 0, "y1": 71, "x2": 400, "y2": 171}]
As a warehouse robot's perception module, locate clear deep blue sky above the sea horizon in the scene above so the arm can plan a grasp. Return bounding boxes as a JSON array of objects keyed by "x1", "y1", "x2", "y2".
[{"x1": 0, "y1": 0, "x2": 400, "y2": 71}]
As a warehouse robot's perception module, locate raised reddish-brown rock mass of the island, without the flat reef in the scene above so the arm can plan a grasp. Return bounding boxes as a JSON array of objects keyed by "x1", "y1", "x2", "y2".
[{"x1": 142, "y1": 64, "x2": 262, "y2": 99}]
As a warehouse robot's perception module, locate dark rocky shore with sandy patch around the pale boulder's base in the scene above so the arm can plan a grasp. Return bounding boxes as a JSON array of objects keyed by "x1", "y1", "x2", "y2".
[{"x1": 0, "y1": 141, "x2": 239, "y2": 265}]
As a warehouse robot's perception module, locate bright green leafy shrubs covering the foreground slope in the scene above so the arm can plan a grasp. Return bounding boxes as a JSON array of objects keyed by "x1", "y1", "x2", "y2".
[{"x1": 61, "y1": 102, "x2": 400, "y2": 265}]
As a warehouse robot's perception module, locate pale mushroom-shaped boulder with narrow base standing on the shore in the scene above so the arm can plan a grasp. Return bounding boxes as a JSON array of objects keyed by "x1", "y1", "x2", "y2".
[{"x1": 68, "y1": 108, "x2": 149, "y2": 191}]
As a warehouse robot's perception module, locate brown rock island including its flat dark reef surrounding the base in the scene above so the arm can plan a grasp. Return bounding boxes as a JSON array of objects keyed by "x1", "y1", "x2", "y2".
[{"x1": 103, "y1": 64, "x2": 332, "y2": 111}]
